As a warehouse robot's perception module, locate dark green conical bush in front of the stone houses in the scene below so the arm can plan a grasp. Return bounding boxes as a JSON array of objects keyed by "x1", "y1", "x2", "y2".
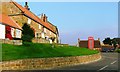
[{"x1": 22, "y1": 23, "x2": 35, "y2": 42}]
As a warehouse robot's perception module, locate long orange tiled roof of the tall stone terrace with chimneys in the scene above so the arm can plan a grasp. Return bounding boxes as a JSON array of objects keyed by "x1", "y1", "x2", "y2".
[{"x1": 12, "y1": 2, "x2": 55, "y2": 32}]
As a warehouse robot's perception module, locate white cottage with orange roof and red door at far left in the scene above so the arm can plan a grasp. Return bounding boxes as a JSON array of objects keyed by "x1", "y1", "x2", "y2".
[{"x1": 0, "y1": 14, "x2": 22, "y2": 40}]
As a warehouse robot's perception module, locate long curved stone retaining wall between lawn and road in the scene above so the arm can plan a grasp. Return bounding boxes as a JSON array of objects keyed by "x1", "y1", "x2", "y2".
[{"x1": 1, "y1": 53, "x2": 101, "y2": 70}]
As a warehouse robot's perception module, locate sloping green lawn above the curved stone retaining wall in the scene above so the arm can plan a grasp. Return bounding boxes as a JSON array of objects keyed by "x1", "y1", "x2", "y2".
[{"x1": 2, "y1": 43, "x2": 98, "y2": 61}]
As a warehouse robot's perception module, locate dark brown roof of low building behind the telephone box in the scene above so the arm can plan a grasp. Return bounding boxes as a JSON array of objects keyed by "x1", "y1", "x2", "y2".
[{"x1": 79, "y1": 40, "x2": 101, "y2": 48}]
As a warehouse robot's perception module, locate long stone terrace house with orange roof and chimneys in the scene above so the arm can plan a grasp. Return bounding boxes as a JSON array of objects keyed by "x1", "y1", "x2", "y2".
[{"x1": 1, "y1": 1, "x2": 59, "y2": 43}]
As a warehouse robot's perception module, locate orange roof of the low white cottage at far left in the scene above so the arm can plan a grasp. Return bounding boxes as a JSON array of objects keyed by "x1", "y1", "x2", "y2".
[{"x1": 0, "y1": 14, "x2": 22, "y2": 30}]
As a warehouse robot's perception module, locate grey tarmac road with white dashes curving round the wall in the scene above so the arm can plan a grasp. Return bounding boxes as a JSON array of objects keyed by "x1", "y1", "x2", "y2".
[{"x1": 2, "y1": 52, "x2": 120, "y2": 72}]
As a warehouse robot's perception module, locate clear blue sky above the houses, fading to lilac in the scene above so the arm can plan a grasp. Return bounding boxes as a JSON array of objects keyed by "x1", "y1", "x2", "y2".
[{"x1": 19, "y1": 2, "x2": 118, "y2": 45}]
